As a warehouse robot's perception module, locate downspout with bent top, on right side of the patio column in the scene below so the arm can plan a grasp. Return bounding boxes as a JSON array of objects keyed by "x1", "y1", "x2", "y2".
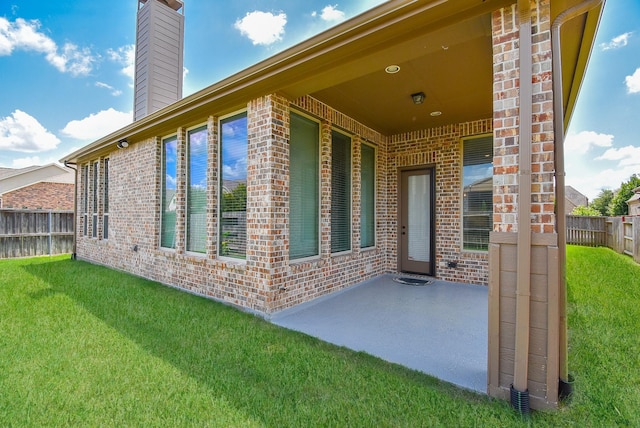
[{"x1": 551, "y1": 0, "x2": 603, "y2": 397}]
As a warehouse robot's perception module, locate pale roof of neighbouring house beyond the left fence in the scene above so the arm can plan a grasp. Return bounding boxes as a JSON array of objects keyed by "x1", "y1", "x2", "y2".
[{"x1": 0, "y1": 163, "x2": 75, "y2": 195}]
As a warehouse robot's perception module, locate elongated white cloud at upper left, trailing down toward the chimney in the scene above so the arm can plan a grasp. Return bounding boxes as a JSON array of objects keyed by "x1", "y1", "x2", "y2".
[{"x1": 0, "y1": 17, "x2": 96, "y2": 76}]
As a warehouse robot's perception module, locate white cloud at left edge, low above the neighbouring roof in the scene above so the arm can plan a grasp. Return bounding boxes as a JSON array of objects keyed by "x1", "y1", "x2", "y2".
[{"x1": 0, "y1": 110, "x2": 60, "y2": 153}]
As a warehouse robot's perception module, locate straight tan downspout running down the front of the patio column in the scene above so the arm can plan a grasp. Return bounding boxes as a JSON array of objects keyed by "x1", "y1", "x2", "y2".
[{"x1": 511, "y1": 0, "x2": 533, "y2": 414}]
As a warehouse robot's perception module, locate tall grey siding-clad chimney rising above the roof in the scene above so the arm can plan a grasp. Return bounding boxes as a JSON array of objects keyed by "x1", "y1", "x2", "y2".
[{"x1": 133, "y1": 0, "x2": 184, "y2": 121}]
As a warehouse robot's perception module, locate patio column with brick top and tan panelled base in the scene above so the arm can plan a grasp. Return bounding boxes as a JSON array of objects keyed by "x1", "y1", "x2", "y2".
[{"x1": 488, "y1": 0, "x2": 559, "y2": 408}]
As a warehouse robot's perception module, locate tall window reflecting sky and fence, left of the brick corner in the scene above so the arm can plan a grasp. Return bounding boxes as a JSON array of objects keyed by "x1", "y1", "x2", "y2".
[{"x1": 218, "y1": 112, "x2": 249, "y2": 259}]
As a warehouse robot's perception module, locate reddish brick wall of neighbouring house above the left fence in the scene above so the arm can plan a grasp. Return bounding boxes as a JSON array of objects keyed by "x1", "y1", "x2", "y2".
[{"x1": 1, "y1": 182, "x2": 74, "y2": 210}]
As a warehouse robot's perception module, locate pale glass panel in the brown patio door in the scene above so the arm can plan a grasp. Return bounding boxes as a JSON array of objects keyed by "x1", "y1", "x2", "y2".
[{"x1": 407, "y1": 174, "x2": 431, "y2": 262}]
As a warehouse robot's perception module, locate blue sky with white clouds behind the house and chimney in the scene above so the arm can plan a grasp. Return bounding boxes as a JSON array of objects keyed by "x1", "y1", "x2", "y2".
[{"x1": 0, "y1": 0, "x2": 640, "y2": 199}]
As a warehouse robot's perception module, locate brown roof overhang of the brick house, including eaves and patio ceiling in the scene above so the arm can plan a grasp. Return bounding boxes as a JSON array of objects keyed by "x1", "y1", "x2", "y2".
[{"x1": 61, "y1": 0, "x2": 602, "y2": 163}]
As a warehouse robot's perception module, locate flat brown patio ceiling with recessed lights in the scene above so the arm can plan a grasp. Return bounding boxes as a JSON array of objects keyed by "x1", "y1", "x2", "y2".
[{"x1": 311, "y1": 14, "x2": 493, "y2": 135}]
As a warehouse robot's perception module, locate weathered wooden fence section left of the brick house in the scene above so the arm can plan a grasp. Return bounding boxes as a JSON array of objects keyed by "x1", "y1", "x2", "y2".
[{"x1": 0, "y1": 209, "x2": 74, "y2": 259}]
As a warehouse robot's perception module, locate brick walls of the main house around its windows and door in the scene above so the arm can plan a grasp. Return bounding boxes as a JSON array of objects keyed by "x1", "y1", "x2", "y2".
[{"x1": 77, "y1": 90, "x2": 492, "y2": 313}]
